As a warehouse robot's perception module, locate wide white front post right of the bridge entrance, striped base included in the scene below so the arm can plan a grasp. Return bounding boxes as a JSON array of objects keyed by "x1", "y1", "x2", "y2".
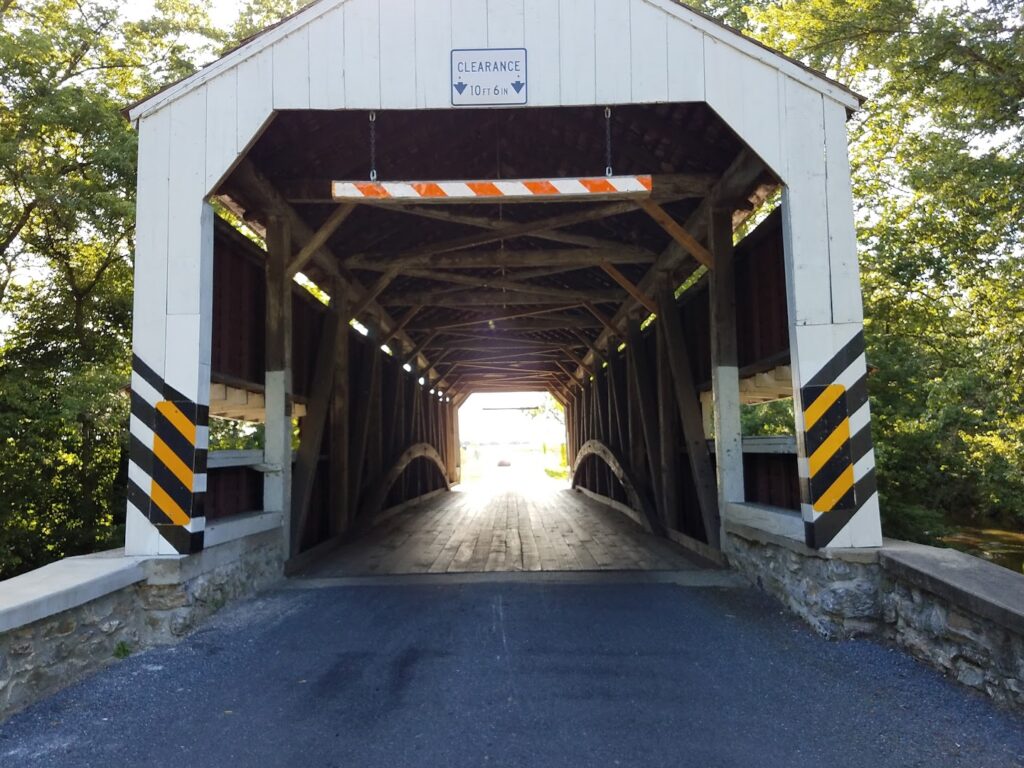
[{"x1": 782, "y1": 83, "x2": 882, "y2": 548}]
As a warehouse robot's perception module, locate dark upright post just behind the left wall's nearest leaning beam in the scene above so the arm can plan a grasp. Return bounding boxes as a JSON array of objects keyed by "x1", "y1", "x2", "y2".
[{"x1": 328, "y1": 282, "x2": 351, "y2": 537}]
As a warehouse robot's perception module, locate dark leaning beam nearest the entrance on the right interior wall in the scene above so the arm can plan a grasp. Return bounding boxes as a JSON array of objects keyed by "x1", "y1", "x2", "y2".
[{"x1": 657, "y1": 286, "x2": 721, "y2": 549}]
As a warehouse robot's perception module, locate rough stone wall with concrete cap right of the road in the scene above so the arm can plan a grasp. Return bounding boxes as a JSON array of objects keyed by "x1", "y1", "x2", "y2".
[{"x1": 725, "y1": 524, "x2": 1024, "y2": 711}]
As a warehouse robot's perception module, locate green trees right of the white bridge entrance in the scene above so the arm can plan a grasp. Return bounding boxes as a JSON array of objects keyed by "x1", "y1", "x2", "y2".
[{"x1": 705, "y1": 0, "x2": 1024, "y2": 539}]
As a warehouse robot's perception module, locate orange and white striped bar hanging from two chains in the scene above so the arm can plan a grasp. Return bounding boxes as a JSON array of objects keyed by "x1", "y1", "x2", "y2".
[{"x1": 331, "y1": 176, "x2": 653, "y2": 204}]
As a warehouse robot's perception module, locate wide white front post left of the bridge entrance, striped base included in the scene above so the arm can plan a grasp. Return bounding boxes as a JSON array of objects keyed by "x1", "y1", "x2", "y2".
[{"x1": 125, "y1": 108, "x2": 214, "y2": 555}]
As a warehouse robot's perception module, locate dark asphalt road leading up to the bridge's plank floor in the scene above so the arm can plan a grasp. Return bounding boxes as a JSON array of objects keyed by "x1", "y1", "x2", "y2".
[{"x1": 0, "y1": 582, "x2": 1024, "y2": 768}]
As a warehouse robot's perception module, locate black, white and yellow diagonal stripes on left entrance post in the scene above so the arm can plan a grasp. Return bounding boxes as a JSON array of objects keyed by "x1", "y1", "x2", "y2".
[{"x1": 128, "y1": 356, "x2": 209, "y2": 554}]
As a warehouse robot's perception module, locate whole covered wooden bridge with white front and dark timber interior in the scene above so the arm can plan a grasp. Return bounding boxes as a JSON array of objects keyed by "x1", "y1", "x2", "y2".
[{"x1": 126, "y1": 0, "x2": 882, "y2": 558}]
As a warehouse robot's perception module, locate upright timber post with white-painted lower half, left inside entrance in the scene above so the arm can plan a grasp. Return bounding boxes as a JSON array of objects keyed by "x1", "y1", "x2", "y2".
[{"x1": 263, "y1": 215, "x2": 292, "y2": 557}]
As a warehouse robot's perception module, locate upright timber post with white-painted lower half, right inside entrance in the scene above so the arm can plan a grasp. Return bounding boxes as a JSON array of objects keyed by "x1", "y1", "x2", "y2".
[{"x1": 708, "y1": 208, "x2": 744, "y2": 519}]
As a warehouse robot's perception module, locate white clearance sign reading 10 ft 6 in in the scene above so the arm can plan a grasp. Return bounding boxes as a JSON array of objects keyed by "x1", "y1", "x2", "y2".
[{"x1": 452, "y1": 48, "x2": 526, "y2": 106}]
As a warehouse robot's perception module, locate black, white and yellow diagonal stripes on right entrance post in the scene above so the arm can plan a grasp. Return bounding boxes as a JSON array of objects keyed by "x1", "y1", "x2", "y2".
[{"x1": 800, "y1": 333, "x2": 877, "y2": 548}]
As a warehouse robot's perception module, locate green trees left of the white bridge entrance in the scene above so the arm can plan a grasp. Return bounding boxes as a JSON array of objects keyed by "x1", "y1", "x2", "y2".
[{"x1": 0, "y1": 0, "x2": 222, "y2": 578}]
